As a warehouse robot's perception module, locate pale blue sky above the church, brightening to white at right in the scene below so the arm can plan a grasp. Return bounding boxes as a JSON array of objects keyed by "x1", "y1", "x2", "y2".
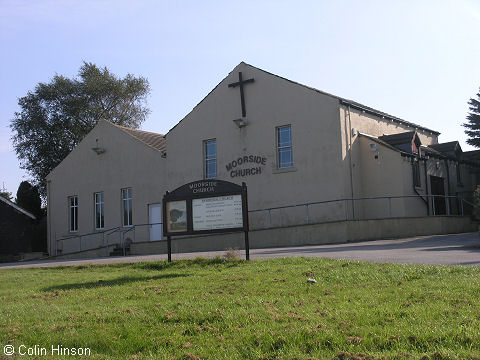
[{"x1": 0, "y1": 0, "x2": 480, "y2": 195}]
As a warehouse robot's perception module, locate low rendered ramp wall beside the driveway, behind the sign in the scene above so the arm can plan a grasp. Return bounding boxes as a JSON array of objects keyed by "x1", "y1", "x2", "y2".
[{"x1": 130, "y1": 216, "x2": 478, "y2": 255}]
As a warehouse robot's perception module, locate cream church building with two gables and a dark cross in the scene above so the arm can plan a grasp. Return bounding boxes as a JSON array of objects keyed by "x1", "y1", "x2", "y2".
[{"x1": 46, "y1": 62, "x2": 479, "y2": 256}]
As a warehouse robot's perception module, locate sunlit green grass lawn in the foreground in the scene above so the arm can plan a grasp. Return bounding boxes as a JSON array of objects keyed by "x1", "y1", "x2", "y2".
[{"x1": 0, "y1": 258, "x2": 480, "y2": 359}]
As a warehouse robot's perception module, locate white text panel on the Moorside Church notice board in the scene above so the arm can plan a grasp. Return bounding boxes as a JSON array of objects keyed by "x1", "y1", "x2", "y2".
[{"x1": 192, "y1": 195, "x2": 243, "y2": 231}]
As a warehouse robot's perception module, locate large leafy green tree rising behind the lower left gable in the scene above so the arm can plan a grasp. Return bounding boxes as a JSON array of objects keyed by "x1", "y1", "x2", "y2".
[{"x1": 10, "y1": 62, "x2": 150, "y2": 196}]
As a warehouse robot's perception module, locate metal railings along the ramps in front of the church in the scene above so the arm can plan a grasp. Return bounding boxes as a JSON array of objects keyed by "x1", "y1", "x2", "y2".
[{"x1": 55, "y1": 195, "x2": 474, "y2": 256}]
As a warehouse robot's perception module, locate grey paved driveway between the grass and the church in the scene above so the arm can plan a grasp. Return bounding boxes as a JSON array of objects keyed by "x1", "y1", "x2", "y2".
[{"x1": 0, "y1": 233, "x2": 480, "y2": 269}]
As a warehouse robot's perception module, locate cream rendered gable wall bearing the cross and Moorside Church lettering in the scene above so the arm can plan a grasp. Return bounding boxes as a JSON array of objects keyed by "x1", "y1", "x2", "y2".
[{"x1": 166, "y1": 63, "x2": 347, "y2": 222}]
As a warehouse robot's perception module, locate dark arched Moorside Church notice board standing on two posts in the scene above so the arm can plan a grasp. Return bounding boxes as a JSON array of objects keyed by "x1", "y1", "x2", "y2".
[{"x1": 162, "y1": 180, "x2": 250, "y2": 262}]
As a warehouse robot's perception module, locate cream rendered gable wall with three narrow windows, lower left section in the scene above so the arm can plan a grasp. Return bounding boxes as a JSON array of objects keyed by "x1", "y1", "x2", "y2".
[{"x1": 47, "y1": 121, "x2": 168, "y2": 255}]
